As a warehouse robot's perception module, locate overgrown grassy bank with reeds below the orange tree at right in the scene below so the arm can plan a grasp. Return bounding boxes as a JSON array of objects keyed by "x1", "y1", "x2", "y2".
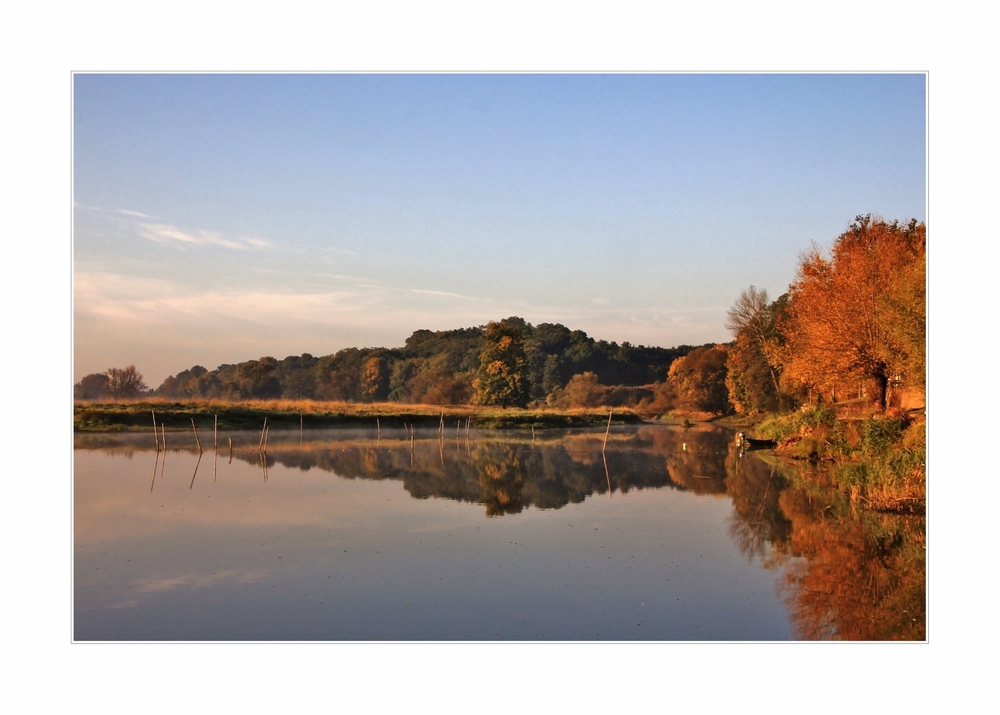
[{"x1": 754, "y1": 407, "x2": 927, "y2": 513}]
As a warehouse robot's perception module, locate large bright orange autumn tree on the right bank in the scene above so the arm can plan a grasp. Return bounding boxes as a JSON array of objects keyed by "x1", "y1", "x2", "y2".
[{"x1": 785, "y1": 214, "x2": 926, "y2": 411}]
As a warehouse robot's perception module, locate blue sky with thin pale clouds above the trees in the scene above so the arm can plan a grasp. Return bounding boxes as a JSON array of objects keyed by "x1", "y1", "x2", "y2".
[{"x1": 72, "y1": 73, "x2": 927, "y2": 387}]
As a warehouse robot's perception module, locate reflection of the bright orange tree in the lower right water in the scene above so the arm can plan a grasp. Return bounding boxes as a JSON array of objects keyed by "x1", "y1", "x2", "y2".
[{"x1": 779, "y1": 472, "x2": 926, "y2": 640}]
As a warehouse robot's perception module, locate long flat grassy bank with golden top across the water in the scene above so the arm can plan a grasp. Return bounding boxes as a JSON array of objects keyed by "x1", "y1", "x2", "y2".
[{"x1": 73, "y1": 399, "x2": 641, "y2": 432}]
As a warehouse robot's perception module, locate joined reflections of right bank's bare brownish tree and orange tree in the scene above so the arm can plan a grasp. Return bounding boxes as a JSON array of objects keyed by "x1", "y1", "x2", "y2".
[{"x1": 727, "y1": 451, "x2": 927, "y2": 641}]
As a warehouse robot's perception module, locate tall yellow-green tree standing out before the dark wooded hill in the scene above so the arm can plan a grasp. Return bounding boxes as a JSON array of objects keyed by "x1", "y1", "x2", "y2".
[{"x1": 473, "y1": 320, "x2": 531, "y2": 407}]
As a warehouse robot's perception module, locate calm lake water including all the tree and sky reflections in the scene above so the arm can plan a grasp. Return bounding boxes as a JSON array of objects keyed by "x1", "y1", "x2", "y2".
[{"x1": 74, "y1": 425, "x2": 925, "y2": 641}]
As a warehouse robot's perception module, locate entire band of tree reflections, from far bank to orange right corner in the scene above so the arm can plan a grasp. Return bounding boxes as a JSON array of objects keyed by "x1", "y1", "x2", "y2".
[{"x1": 77, "y1": 425, "x2": 926, "y2": 640}]
